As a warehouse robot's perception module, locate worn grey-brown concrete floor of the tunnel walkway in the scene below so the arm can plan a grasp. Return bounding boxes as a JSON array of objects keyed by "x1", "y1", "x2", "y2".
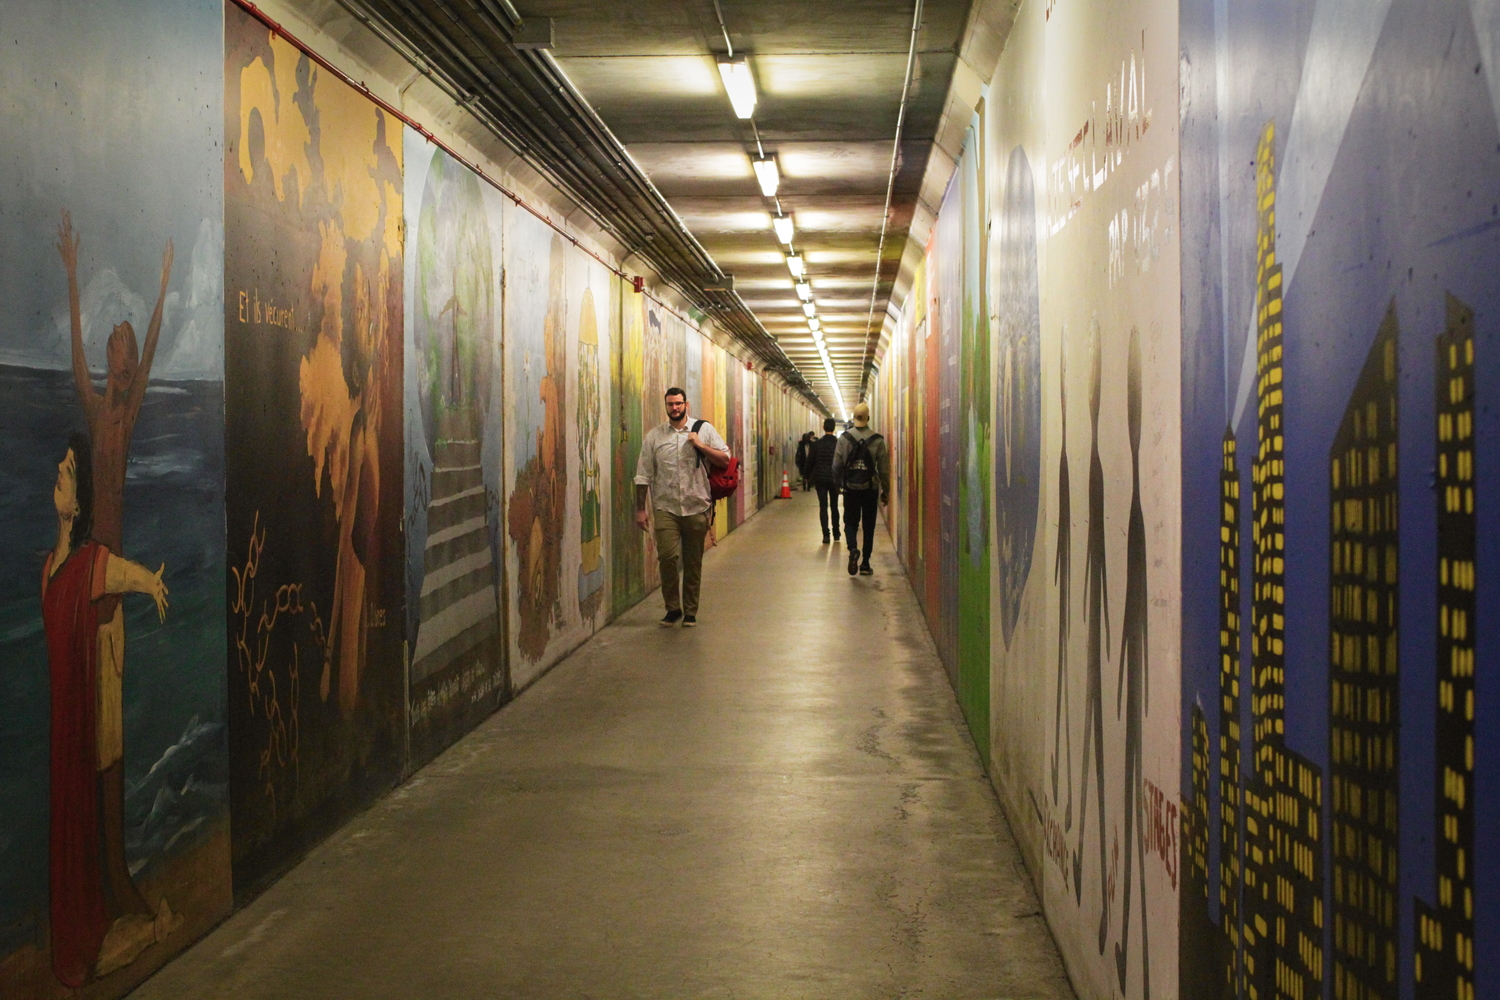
[{"x1": 134, "y1": 493, "x2": 1074, "y2": 1000}]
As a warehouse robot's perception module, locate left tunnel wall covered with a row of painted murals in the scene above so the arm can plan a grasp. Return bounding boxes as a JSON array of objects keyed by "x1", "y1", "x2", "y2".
[{"x1": 0, "y1": 0, "x2": 810, "y2": 999}]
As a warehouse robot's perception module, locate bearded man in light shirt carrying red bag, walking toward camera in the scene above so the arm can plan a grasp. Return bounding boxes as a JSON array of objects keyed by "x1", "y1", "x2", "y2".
[{"x1": 636, "y1": 387, "x2": 729, "y2": 628}]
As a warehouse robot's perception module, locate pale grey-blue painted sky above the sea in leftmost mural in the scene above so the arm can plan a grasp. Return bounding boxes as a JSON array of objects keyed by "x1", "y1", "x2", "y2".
[{"x1": 0, "y1": 0, "x2": 224, "y2": 379}]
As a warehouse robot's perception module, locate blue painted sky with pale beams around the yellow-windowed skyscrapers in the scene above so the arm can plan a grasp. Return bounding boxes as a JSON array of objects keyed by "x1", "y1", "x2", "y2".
[{"x1": 1182, "y1": 0, "x2": 1500, "y2": 997}]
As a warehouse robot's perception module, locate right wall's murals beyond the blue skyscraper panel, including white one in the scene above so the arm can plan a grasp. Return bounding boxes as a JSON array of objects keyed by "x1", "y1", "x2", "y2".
[{"x1": 879, "y1": 3, "x2": 1181, "y2": 999}]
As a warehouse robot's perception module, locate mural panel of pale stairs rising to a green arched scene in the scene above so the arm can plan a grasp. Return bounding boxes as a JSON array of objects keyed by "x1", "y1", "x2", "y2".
[{"x1": 404, "y1": 129, "x2": 509, "y2": 763}]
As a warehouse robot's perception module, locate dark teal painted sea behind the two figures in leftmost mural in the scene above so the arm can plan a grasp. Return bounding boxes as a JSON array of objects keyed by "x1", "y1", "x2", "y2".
[{"x1": 0, "y1": 366, "x2": 228, "y2": 954}]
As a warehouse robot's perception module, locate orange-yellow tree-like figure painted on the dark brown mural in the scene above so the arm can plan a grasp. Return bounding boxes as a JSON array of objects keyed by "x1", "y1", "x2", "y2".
[{"x1": 236, "y1": 27, "x2": 402, "y2": 717}]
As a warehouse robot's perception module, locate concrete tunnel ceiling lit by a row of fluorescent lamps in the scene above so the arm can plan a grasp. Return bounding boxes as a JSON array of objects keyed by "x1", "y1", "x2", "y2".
[{"x1": 528, "y1": 0, "x2": 969, "y2": 411}]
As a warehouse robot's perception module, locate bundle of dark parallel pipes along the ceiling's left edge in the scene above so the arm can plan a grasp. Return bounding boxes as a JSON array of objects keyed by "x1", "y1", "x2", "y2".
[{"x1": 339, "y1": 0, "x2": 824, "y2": 409}]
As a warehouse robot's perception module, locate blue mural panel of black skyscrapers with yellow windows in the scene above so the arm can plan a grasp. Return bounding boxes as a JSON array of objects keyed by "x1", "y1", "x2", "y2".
[{"x1": 1181, "y1": 0, "x2": 1500, "y2": 1000}]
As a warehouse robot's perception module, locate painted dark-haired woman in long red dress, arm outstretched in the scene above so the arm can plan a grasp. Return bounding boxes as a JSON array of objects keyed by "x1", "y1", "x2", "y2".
[{"x1": 42, "y1": 433, "x2": 180, "y2": 988}]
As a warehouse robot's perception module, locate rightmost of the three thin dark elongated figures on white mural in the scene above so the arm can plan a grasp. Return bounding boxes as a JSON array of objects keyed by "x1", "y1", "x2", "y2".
[{"x1": 1115, "y1": 327, "x2": 1151, "y2": 997}]
